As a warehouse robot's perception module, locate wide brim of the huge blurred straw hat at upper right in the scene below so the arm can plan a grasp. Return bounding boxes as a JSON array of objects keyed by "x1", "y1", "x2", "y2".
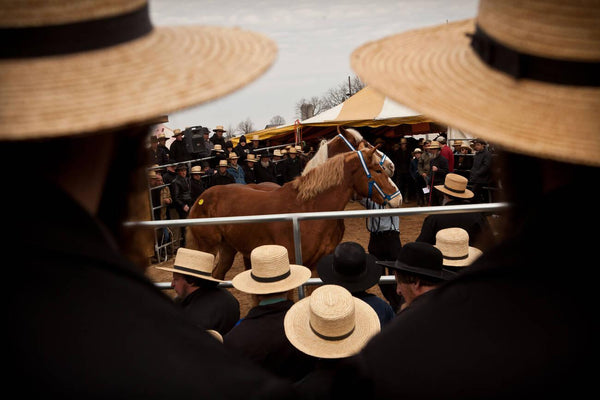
[{"x1": 351, "y1": 20, "x2": 600, "y2": 166}]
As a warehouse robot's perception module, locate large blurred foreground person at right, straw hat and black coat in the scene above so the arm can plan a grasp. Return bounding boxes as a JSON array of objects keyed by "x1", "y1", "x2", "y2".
[{"x1": 318, "y1": 0, "x2": 600, "y2": 399}]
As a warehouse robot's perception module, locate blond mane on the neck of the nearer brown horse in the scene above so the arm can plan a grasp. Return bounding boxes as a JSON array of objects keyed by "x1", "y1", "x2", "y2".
[{"x1": 291, "y1": 153, "x2": 348, "y2": 201}]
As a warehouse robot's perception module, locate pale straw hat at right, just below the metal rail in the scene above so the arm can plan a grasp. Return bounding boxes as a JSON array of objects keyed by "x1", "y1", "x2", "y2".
[{"x1": 435, "y1": 228, "x2": 482, "y2": 267}]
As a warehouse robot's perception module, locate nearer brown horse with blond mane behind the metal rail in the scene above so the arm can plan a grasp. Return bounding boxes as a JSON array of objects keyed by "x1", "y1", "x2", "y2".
[{"x1": 186, "y1": 148, "x2": 401, "y2": 279}]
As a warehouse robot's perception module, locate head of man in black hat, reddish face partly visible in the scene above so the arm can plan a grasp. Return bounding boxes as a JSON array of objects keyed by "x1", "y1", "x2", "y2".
[{"x1": 377, "y1": 242, "x2": 456, "y2": 309}]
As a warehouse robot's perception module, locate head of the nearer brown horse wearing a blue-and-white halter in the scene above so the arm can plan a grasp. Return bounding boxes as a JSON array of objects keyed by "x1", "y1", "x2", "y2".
[{"x1": 348, "y1": 147, "x2": 402, "y2": 208}]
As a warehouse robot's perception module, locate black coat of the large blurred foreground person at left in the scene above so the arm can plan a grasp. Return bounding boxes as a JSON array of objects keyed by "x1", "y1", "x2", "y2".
[{"x1": 8, "y1": 182, "x2": 292, "y2": 399}]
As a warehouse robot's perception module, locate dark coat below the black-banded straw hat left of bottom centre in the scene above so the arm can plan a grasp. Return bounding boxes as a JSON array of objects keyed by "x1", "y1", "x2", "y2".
[{"x1": 223, "y1": 300, "x2": 314, "y2": 381}]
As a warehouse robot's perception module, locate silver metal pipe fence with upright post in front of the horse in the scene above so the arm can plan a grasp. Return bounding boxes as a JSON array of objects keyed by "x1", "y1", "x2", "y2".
[{"x1": 125, "y1": 203, "x2": 510, "y2": 298}]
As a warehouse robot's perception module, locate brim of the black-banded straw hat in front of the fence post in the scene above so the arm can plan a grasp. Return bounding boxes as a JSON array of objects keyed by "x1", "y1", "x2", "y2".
[{"x1": 231, "y1": 264, "x2": 311, "y2": 294}]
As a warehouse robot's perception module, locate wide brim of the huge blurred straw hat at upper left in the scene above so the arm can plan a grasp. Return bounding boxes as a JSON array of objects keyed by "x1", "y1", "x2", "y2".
[{"x1": 0, "y1": 26, "x2": 277, "y2": 140}]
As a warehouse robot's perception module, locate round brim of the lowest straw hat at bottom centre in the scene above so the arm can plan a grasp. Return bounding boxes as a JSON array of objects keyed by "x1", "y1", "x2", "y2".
[{"x1": 283, "y1": 297, "x2": 380, "y2": 358}]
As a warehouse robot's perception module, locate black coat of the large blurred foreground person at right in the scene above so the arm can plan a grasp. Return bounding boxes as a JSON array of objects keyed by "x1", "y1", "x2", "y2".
[{"x1": 322, "y1": 183, "x2": 599, "y2": 399}]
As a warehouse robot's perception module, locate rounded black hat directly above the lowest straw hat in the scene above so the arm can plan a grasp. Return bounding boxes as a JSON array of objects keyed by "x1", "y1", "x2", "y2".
[{"x1": 317, "y1": 242, "x2": 383, "y2": 292}]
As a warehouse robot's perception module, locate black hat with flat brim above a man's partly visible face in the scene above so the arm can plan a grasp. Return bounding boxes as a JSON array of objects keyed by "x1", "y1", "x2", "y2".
[{"x1": 377, "y1": 242, "x2": 456, "y2": 281}]
